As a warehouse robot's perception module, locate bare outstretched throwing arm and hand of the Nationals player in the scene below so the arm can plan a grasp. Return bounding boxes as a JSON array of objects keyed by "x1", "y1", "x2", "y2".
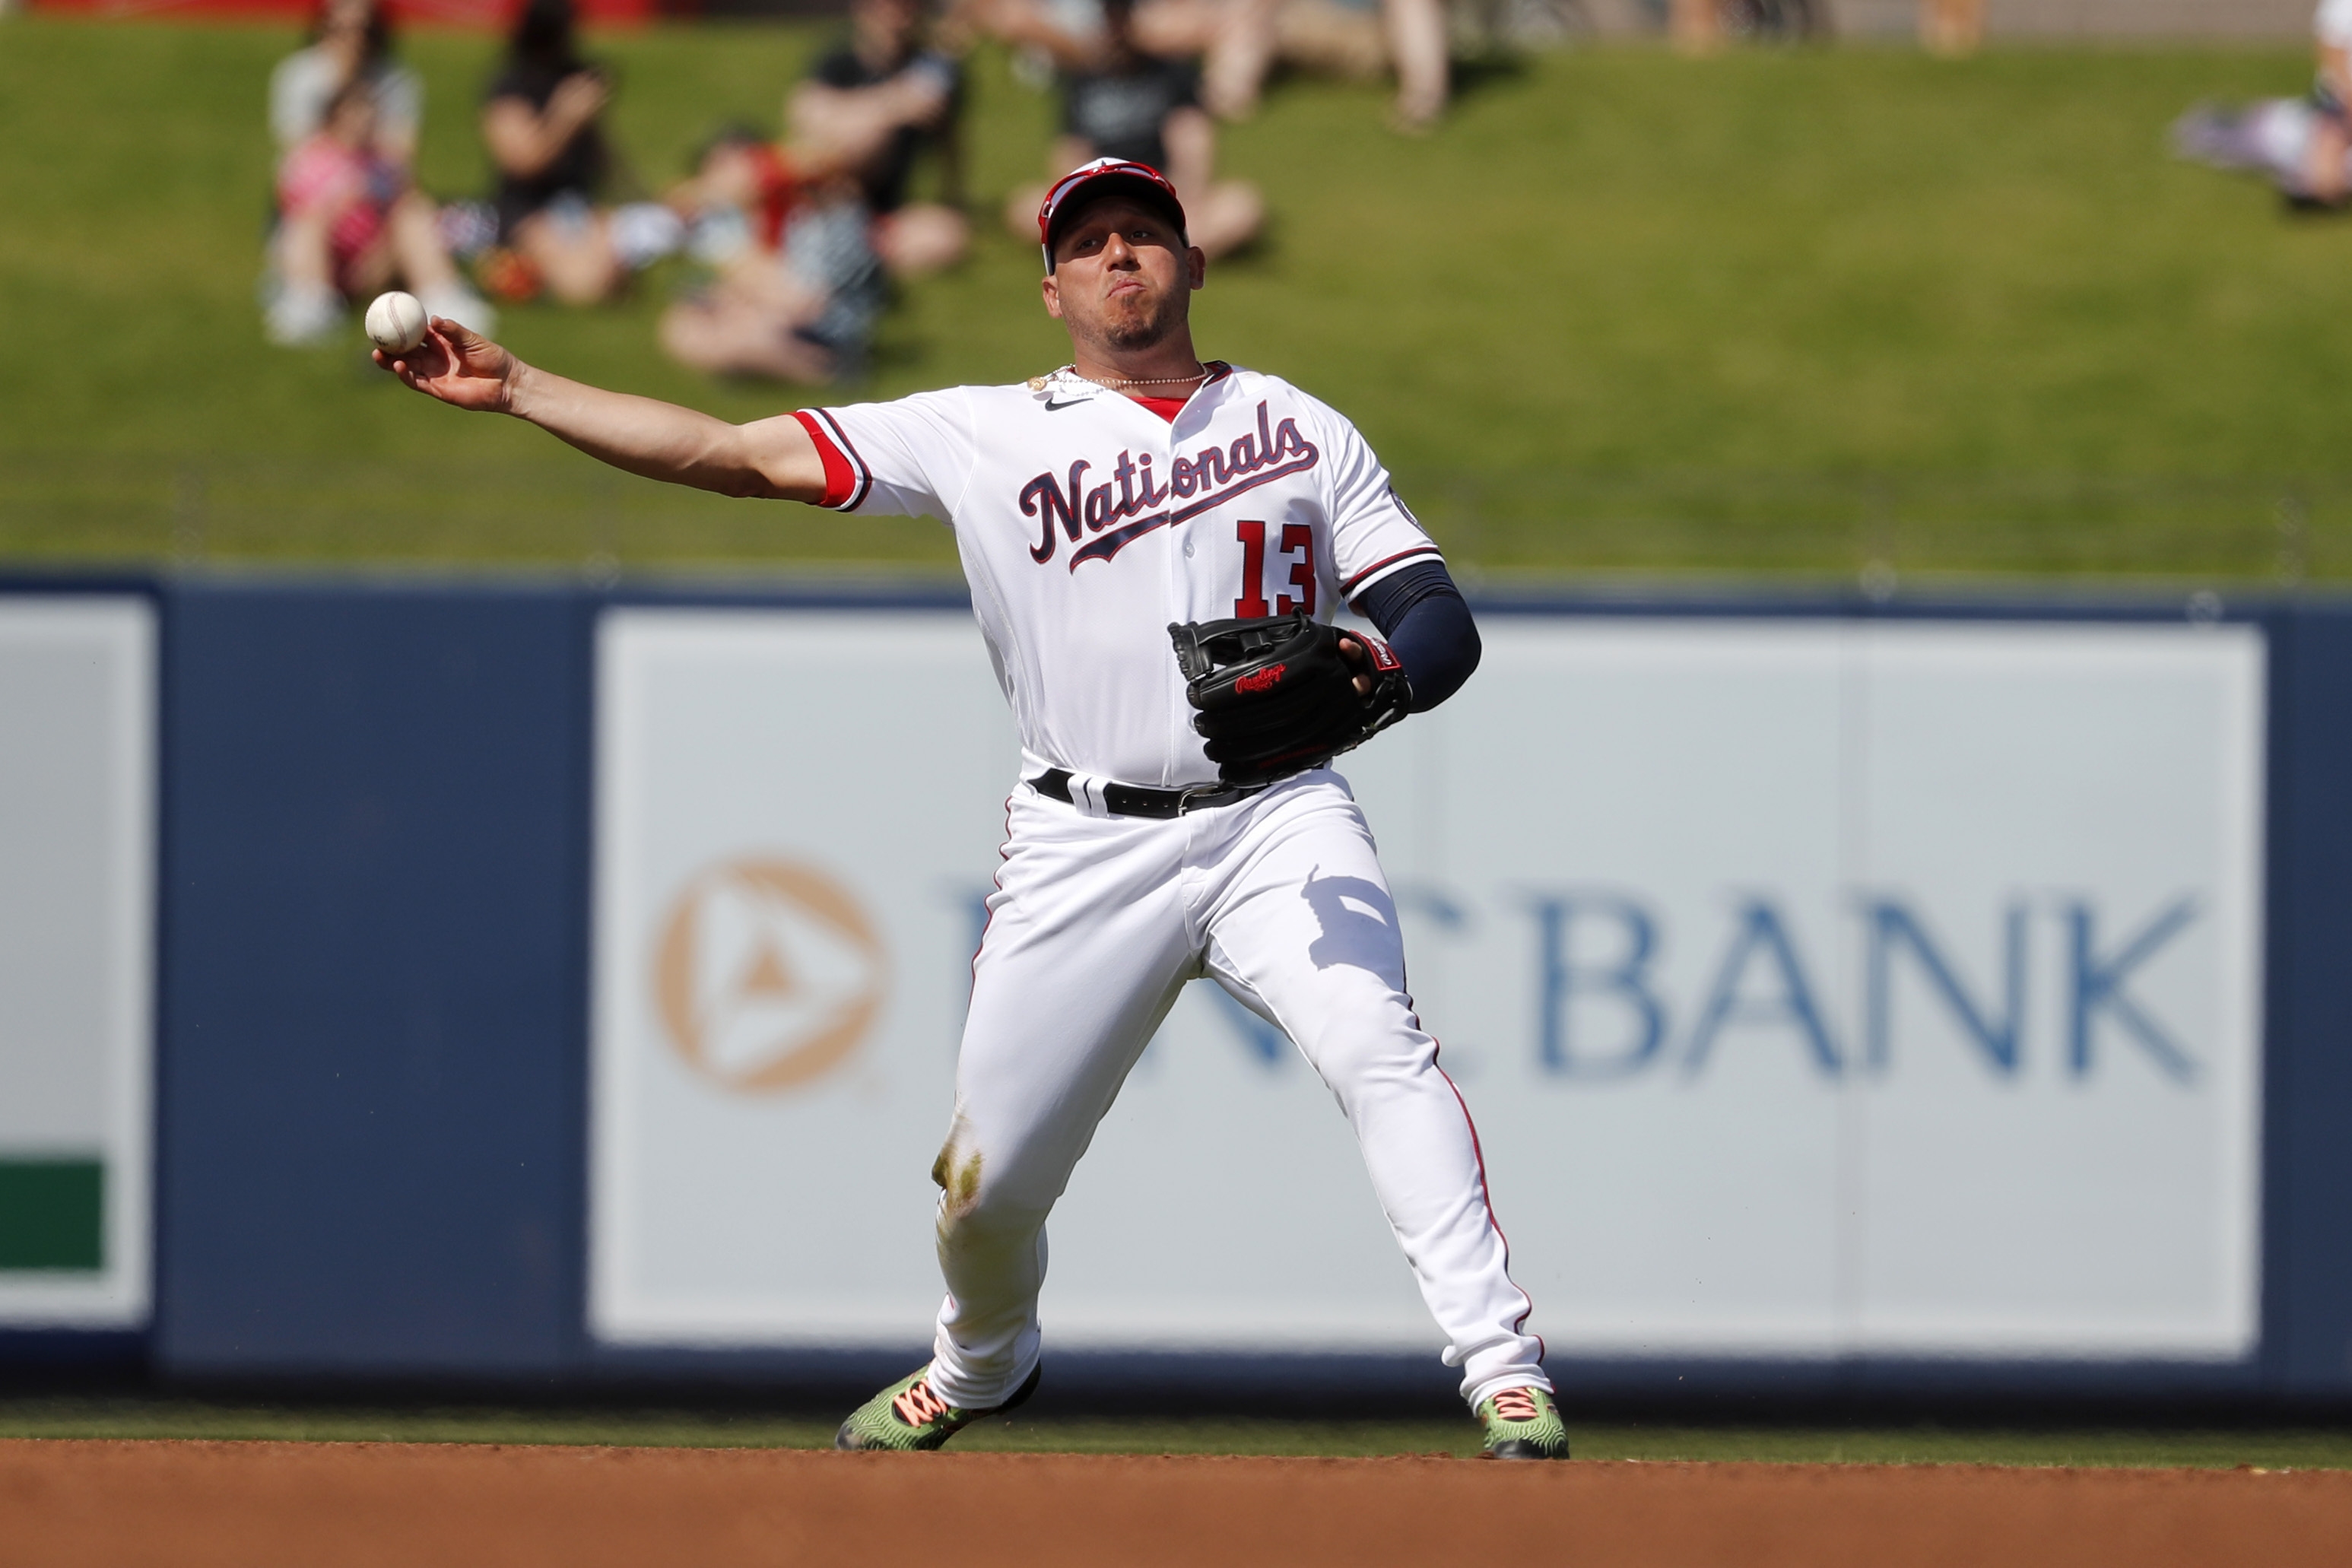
[{"x1": 376, "y1": 315, "x2": 826, "y2": 503}]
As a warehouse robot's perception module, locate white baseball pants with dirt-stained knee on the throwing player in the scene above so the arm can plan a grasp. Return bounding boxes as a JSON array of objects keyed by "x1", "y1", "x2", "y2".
[{"x1": 932, "y1": 769, "x2": 1550, "y2": 1411}]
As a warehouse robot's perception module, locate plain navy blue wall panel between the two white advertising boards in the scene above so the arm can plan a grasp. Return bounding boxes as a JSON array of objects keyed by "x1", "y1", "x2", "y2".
[{"x1": 155, "y1": 586, "x2": 588, "y2": 1376}]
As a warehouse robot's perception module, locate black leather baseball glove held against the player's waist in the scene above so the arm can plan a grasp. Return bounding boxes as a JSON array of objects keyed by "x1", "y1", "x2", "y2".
[{"x1": 1169, "y1": 611, "x2": 1414, "y2": 786}]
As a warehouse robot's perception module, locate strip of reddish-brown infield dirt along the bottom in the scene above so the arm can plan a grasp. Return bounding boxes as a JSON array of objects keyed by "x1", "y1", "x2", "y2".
[{"x1": 0, "y1": 1441, "x2": 2352, "y2": 1568}]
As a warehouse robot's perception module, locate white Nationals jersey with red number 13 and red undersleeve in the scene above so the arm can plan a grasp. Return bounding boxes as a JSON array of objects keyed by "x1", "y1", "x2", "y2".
[{"x1": 798, "y1": 364, "x2": 1437, "y2": 788}]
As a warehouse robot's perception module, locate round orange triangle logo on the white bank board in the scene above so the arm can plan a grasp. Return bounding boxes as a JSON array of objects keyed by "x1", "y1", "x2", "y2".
[{"x1": 654, "y1": 858, "x2": 889, "y2": 1093}]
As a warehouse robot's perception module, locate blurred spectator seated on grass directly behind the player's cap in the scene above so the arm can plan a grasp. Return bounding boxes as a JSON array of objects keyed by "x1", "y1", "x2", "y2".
[{"x1": 988, "y1": 0, "x2": 1265, "y2": 256}]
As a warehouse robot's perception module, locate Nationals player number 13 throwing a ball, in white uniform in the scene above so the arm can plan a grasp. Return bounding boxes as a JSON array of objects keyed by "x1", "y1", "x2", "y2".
[{"x1": 376, "y1": 157, "x2": 1569, "y2": 1458}]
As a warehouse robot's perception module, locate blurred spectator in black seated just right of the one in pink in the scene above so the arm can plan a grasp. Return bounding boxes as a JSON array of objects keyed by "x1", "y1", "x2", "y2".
[{"x1": 482, "y1": 0, "x2": 628, "y2": 306}]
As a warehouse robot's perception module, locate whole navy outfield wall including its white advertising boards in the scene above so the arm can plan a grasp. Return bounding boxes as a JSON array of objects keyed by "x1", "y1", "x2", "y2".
[{"x1": 0, "y1": 581, "x2": 2352, "y2": 1396}]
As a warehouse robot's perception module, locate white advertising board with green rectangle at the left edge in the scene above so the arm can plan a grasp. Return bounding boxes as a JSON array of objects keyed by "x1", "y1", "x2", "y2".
[{"x1": 0, "y1": 595, "x2": 155, "y2": 1328}]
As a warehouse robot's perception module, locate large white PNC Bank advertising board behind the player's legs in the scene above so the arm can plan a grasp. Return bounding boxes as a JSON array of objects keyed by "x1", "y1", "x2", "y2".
[{"x1": 590, "y1": 609, "x2": 2265, "y2": 1359}]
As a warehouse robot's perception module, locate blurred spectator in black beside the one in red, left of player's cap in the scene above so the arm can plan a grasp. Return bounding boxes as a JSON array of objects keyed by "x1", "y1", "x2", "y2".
[{"x1": 786, "y1": 0, "x2": 971, "y2": 278}]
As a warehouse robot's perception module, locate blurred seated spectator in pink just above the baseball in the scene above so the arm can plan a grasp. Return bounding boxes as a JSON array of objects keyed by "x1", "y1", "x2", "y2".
[{"x1": 268, "y1": 75, "x2": 494, "y2": 343}]
